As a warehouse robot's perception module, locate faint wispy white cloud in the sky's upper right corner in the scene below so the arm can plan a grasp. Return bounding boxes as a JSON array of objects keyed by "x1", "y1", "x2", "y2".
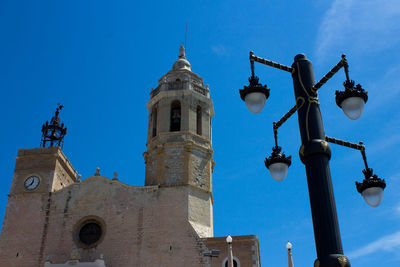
[{"x1": 316, "y1": 0, "x2": 400, "y2": 57}]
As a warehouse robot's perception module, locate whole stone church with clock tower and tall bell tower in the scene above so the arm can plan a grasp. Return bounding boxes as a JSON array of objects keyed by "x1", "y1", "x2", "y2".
[{"x1": 0, "y1": 46, "x2": 260, "y2": 267}]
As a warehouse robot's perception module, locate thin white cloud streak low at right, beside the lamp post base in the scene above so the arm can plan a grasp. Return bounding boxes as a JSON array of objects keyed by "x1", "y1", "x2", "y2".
[{"x1": 348, "y1": 231, "x2": 400, "y2": 259}]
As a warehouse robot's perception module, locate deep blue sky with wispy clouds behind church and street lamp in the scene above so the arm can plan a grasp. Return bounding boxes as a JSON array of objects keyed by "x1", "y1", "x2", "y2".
[{"x1": 0, "y1": 0, "x2": 400, "y2": 267}]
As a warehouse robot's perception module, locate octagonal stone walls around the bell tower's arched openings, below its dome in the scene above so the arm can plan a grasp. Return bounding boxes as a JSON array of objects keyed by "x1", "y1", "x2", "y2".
[{"x1": 144, "y1": 91, "x2": 213, "y2": 189}]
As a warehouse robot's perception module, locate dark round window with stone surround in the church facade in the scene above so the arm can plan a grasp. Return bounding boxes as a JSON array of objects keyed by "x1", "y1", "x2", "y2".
[{"x1": 74, "y1": 216, "x2": 105, "y2": 248}]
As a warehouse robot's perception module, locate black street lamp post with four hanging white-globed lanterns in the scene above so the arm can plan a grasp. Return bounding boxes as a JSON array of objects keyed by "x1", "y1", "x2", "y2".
[{"x1": 239, "y1": 52, "x2": 386, "y2": 267}]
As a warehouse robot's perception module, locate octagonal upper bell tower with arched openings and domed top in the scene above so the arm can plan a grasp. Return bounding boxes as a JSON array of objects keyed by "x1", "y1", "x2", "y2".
[{"x1": 144, "y1": 46, "x2": 214, "y2": 192}]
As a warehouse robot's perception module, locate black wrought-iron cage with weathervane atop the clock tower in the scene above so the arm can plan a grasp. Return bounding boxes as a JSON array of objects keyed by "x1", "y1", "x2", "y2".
[{"x1": 40, "y1": 104, "x2": 67, "y2": 148}]
